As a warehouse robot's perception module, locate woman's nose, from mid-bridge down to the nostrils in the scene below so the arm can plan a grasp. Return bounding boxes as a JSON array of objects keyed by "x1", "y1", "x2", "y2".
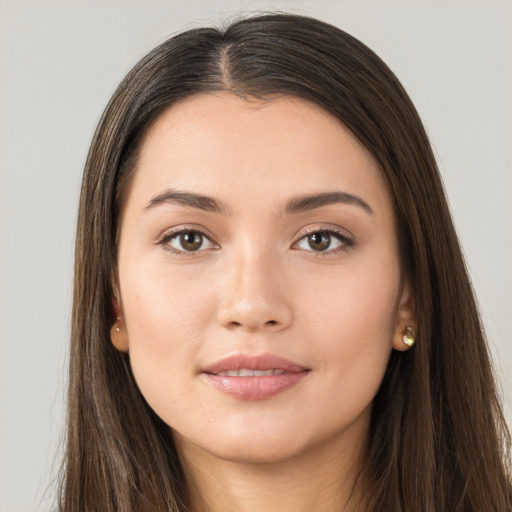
[{"x1": 217, "y1": 247, "x2": 292, "y2": 332}]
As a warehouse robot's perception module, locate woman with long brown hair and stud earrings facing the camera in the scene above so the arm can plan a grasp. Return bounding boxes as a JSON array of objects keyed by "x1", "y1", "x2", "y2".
[{"x1": 61, "y1": 14, "x2": 512, "y2": 512}]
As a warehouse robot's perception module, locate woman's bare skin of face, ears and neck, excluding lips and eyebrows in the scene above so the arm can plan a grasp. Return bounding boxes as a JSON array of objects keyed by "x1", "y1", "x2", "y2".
[{"x1": 112, "y1": 93, "x2": 415, "y2": 512}]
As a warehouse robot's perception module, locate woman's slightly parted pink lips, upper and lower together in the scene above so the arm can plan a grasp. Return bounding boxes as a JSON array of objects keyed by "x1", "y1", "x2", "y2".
[{"x1": 202, "y1": 354, "x2": 310, "y2": 400}]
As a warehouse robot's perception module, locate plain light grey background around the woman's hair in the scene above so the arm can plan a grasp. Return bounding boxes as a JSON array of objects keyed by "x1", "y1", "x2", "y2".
[{"x1": 0, "y1": 0, "x2": 512, "y2": 512}]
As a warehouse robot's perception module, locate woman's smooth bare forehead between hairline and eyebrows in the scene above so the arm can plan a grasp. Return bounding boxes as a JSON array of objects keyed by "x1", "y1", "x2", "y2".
[{"x1": 127, "y1": 92, "x2": 388, "y2": 215}]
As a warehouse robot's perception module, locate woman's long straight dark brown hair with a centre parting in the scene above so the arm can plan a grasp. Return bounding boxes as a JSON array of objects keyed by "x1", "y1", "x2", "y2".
[{"x1": 60, "y1": 13, "x2": 512, "y2": 512}]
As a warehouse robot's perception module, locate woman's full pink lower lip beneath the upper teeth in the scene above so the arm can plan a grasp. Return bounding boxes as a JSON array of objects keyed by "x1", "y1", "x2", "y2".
[{"x1": 203, "y1": 371, "x2": 308, "y2": 400}]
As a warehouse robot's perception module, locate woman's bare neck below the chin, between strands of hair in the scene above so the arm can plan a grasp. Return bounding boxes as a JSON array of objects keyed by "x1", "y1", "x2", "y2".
[{"x1": 176, "y1": 422, "x2": 366, "y2": 512}]
